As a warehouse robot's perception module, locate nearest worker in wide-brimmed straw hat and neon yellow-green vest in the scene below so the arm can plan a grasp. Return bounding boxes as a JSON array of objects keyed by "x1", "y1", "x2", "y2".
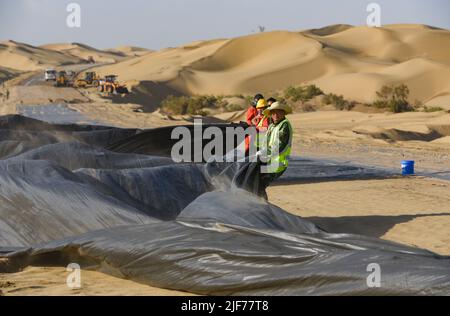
[{"x1": 257, "y1": 102, "x2": 293, "y2": 199}]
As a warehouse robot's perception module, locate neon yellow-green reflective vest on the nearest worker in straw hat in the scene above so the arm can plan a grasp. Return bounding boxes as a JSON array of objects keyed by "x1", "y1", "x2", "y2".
[{"x1": 267, "y1": 119, "x2": 293, "y2": 173}]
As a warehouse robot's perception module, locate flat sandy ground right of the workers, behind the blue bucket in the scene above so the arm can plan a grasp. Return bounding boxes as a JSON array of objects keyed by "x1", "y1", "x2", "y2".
[{"x1": 290, "y1": 111, "x2": 450, "y2": 179}]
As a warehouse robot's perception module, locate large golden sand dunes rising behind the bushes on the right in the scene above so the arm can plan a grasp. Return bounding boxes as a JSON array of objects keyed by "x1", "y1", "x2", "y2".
[{"x1": 90, "y1": 24, "x2": 450, "y2": 108}]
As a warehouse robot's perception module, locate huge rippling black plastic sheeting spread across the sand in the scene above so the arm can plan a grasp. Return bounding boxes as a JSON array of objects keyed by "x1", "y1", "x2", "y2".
[{"x1": 0, "y1": 116, "x2": 450, "y2": 295}]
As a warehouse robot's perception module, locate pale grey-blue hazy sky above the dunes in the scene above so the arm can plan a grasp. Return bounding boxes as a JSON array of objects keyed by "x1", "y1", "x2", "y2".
[{"x1": 0, "y1": 0, "x2": 450, "y2": 49}]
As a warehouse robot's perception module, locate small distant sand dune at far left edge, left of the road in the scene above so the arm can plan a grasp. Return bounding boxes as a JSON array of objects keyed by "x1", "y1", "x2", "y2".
[{"x1": 0, "y1": 41, "x2": 84, "y2": 71}]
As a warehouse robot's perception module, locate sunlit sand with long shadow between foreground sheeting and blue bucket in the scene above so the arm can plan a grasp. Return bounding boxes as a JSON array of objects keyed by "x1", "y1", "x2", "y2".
[{"x1": 268, "y1": 177, "x2": 450, "y2": 255}]
